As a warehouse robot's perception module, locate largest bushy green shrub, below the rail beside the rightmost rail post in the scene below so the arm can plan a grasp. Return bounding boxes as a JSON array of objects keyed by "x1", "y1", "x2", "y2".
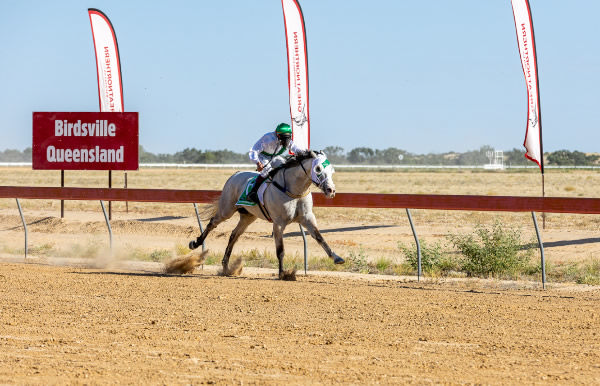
[{"x1": 448, "y1": 221, "x2": 533, "y2": 277}]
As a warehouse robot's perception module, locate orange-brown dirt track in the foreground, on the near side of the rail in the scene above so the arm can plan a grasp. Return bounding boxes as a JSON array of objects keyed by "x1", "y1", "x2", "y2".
[{"x1": 0, "y1": 258, "x2": 600, "y2": 384}]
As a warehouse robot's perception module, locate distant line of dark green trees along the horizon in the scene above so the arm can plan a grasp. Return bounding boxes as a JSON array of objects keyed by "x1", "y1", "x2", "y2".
[{"x1": 0, "y1": 146, "x2": 600, "y2": 166}]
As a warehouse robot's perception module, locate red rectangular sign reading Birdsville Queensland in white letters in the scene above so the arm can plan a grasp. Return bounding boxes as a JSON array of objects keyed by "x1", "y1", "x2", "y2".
[{"x1": 32, "y1": 112, "x2": 139, "y2": 170}]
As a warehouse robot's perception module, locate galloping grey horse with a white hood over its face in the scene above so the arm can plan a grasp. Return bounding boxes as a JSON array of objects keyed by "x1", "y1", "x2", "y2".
[{"x1": 189, "y1": 151, "x2": 344, "y2": 279}]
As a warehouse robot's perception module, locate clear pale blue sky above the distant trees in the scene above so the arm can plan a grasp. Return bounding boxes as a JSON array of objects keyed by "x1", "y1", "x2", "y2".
[{"x1": 0, "y1": 0, "x2": 600, "y2": 153}]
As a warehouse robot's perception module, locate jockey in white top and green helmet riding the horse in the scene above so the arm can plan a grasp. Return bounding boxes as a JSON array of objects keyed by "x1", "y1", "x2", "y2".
[{"x1": 248, "y1": 123, "x2": 302, "y2": 204}]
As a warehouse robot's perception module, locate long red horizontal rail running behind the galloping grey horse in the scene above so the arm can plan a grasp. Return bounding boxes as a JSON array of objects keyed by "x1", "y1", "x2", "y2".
[{"x1": 0, "y1": 186, "x2": 600, "y2": 214}]
